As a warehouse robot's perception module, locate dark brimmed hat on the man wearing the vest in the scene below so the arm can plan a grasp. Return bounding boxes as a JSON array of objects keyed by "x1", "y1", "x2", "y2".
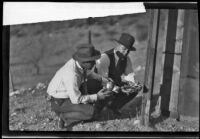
[{"x1": 114, "y1": 33, "x2": 136, "y2": 51}]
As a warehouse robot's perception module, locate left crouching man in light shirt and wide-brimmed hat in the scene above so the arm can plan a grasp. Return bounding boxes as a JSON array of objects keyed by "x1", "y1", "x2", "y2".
[{"x1": 47, "y1": 44, "x2": 113, "y2": 128}]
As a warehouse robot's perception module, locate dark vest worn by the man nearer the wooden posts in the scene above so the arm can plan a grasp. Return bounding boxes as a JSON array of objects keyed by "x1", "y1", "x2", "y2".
[{"x1": 105, "y1": 49, "x2": 127, "y2": 86}]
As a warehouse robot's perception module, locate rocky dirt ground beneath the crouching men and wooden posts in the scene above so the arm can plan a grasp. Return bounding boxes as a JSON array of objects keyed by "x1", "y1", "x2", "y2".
[{"x1": 9, "y1": 84, "x2": 199, "y2": 132}]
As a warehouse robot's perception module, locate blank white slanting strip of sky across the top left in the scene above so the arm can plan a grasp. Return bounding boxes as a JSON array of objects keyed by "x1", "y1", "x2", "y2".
[{"x1": 3, "y1": 2, "x2": 146, "y2": 25}]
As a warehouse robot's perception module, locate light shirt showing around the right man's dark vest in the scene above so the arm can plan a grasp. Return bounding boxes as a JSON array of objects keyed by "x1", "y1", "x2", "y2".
[{"x1": 96, "y1": 49, "x2": 133, "y2": 77}]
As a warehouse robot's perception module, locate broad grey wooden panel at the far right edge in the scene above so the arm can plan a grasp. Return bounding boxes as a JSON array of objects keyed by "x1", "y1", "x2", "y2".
[{"x1": 178, "y1": 9, "x2": 199, "y2": 117}]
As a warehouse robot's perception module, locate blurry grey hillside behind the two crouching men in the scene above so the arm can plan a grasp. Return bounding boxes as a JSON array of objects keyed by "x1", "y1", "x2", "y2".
[{"x1": 10, "y1": 13, "x2": 152, "y2": 89}]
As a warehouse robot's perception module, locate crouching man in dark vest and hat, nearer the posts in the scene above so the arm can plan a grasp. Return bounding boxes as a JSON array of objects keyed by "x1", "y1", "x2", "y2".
[{"x1": 96, "y1": 33, "x2": 136, "y2": 115}]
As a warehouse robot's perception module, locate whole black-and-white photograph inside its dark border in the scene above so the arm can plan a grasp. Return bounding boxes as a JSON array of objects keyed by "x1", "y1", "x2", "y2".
[{"x1": 2, "y1": 2, "x2": 199, "y2": 137}]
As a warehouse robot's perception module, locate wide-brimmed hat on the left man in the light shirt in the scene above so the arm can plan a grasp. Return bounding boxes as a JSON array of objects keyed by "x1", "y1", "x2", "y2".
[{"x1": 72, "y1": 44, "x2": 101, "y2": 62}]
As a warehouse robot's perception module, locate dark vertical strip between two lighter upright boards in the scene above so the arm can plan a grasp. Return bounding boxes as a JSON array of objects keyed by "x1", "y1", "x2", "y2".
[{"x1": 160, "y1": 9, "x2": 178, "y2": 116}]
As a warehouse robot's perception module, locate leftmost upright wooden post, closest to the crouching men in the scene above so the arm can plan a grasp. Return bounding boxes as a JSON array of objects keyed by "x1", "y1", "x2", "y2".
[{"x1": 141, "y1": 9, "x2": 160, "y2": 126}]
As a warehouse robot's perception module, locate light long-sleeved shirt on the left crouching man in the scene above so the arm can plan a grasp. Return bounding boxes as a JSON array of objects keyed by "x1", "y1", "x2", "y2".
[{"x1": 47, "y1": 59, "x2": 100, "y2": 104}]
